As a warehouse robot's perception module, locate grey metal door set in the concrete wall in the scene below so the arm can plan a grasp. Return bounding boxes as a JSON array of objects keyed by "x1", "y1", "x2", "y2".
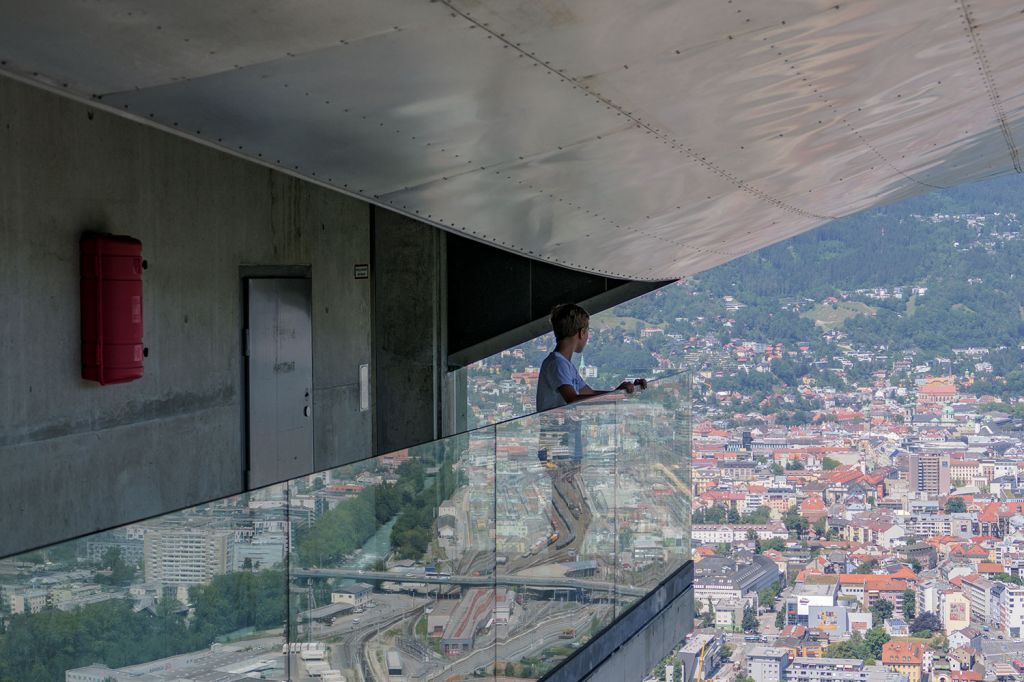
[{"x1": 246, "y1": 279, "x2": 313, "y2": 487}]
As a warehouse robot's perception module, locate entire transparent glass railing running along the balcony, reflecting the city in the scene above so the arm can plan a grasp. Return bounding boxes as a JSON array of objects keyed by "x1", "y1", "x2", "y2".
[{"x1": 0, "y1": 375, "x2": 691, "y2": 682}]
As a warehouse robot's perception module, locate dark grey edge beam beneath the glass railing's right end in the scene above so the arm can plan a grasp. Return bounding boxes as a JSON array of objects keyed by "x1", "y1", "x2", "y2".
[{"x1": 541, "y1": 561, "x2": 693, "y2": 682}]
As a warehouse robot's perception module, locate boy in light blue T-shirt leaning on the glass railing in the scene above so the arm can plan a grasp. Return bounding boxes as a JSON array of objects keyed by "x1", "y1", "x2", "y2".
[{"x1": 537, "y1": 303, "x2": 647, "y2": 412}]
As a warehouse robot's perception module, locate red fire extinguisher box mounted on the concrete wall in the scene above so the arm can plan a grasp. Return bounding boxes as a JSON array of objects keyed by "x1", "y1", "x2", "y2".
[{"x1": 80, "y1": 233, "x2": 142, "y2": 384}]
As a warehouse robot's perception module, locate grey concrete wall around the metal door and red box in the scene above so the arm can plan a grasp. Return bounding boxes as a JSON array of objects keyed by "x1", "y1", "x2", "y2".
[{"x1": 0, "y1": 74, "x2": 372, "y2": 555}]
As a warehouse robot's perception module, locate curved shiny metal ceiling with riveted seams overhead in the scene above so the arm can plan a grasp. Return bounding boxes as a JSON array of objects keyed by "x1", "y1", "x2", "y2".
[{"x1": 0, "y1": 0, "x2": 1024, "y2": 280}]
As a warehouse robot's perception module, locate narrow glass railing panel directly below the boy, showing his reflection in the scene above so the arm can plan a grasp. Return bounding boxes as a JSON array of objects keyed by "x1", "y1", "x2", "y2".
[{"x1": 495, "y1": 395, "x2": 617, "y2": 679}]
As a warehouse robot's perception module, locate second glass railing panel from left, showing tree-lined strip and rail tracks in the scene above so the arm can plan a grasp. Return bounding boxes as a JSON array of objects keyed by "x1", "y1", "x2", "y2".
[{"x1": 290, "y1": 427, "x2": 495, "y2": 682}]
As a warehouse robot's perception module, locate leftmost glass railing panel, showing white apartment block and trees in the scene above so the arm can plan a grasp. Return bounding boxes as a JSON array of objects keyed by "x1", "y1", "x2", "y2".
[{"x1": 0, "y1": 484, "x2": 292, "y2": 682}]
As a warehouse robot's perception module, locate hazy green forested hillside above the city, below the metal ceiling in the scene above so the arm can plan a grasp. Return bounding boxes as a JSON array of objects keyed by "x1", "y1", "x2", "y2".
[{"x1": 615, "y1": 176, "x2": 1024, "y2": 354}]
